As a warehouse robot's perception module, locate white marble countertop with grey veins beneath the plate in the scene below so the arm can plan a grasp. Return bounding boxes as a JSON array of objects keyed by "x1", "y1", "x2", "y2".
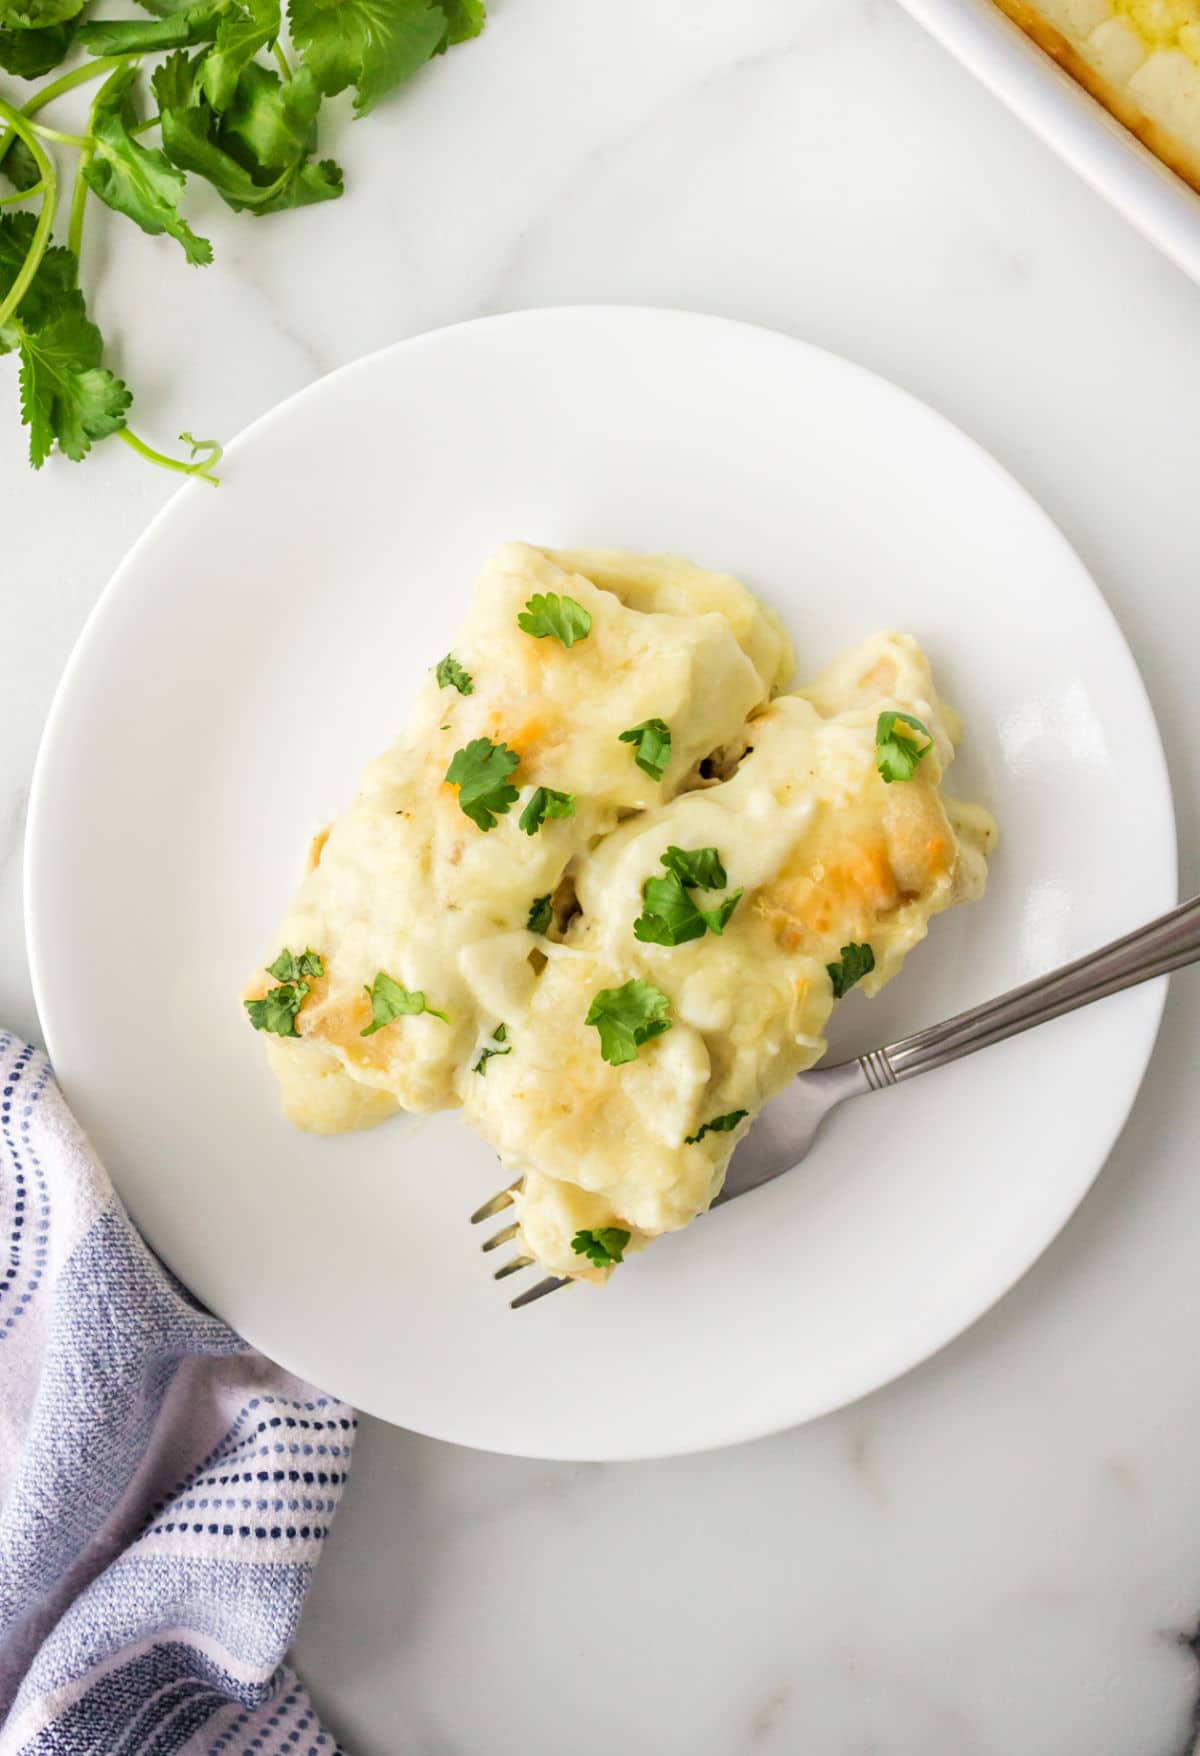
[{"x1": 0, "y1": 0, "x2": 1200, "y2": 1756}]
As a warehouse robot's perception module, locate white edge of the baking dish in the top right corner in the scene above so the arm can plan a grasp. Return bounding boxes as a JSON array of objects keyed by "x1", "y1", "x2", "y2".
[{"x1": 900, "y1": 0, "x2": 1200, "y2": 281}]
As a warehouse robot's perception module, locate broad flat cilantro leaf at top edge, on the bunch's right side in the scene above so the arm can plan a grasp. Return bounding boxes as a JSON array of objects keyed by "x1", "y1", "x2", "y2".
[{"x1": 288, "y1": 0, "x2": 453, "y2": 116}]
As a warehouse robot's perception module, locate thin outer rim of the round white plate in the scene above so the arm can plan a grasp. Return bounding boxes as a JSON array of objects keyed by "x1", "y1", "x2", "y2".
[{"x1": 23, "y1": 302, "x2": 1179, "y2": 1463}]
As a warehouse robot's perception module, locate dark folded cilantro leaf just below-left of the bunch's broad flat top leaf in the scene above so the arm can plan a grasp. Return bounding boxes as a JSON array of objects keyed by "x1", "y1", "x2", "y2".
[{"x1": 151, "y1": 56, "x2": 343, "y2": 214}]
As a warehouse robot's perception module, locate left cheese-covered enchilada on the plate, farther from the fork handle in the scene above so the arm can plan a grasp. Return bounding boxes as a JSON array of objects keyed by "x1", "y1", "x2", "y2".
[{"x1": 248, "y1": 543, "x2": 791, "y2": 1133}]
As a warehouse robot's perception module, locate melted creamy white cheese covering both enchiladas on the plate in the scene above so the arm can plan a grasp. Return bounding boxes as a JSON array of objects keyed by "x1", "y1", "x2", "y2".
[{"x1": 248, "y1": 544, "x2": 994, "y2": 1278}]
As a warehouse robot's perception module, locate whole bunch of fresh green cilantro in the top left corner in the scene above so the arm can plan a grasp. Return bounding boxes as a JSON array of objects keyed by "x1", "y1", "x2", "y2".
[{"x1": 0, "y1": 0, "x2": 488, "y2": 474}]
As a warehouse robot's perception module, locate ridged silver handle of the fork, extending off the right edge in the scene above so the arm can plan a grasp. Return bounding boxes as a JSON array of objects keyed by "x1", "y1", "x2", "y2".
[{"x1": 859, "y1": 897, "x2": 1200, "y2": 1090}]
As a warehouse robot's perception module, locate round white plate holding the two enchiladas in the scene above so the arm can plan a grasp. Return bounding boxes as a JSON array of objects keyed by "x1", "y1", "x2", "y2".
[{"x1": 26, "y1": 309, "x2": 1175, "y2": 1459}]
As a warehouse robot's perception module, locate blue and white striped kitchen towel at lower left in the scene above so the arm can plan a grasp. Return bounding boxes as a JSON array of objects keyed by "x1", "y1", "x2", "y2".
[{"x1": 0, "y1": 1033, "x2": 355, "y2": 1756}]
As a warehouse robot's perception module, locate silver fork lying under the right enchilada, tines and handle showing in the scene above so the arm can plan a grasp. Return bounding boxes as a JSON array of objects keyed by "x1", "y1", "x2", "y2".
[{"x1": 471, "y1": 897, "x2": 1200, "y2": 1310}]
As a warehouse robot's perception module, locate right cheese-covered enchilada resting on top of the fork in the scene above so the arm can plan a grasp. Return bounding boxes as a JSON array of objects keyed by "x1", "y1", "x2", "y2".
[{"x1": 460, "y1": 636, "x2": 993, "y2": 1273}]
